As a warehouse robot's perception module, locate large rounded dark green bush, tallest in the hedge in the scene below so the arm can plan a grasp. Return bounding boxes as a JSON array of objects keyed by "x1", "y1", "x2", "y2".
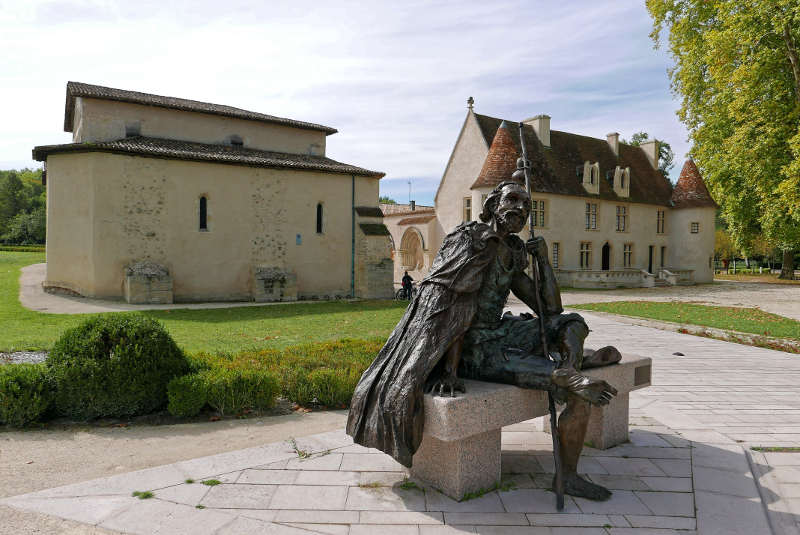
[{"x1": 46, "y1": 314, "x2": 189, "y2": 420}]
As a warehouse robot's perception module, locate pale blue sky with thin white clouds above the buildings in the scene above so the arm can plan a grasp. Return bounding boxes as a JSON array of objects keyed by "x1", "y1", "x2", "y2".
[{"x1": 0, "y1": 0, "x2": 689, "y2": 205}]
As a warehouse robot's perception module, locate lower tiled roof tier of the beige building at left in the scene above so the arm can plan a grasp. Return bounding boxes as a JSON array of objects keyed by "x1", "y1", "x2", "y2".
[{"x1": 33, "y1": 136, "x2": 384, "y2": 178}]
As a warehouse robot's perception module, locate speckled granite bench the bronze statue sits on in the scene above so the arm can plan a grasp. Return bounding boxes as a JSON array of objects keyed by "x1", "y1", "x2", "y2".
[{"x1": 410, "y1": 355, "x2": 651, "y2": 499}]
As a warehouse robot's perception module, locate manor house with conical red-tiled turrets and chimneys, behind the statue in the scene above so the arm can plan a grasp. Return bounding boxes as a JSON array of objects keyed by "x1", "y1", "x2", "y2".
[{"x1": 381, "y1": 100, "x2": 717, "y2": 288}]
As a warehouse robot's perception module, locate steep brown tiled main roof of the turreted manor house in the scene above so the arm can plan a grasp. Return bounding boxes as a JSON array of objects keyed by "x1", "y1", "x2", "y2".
[{"x1": 473, "y1": 113, "x2": 672, "y2": 206}]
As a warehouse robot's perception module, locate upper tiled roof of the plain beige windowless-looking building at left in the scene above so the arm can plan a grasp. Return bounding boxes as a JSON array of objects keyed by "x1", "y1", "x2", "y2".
[{"x1": 64, "y1": 82, "x2": 337, "y2": 136}]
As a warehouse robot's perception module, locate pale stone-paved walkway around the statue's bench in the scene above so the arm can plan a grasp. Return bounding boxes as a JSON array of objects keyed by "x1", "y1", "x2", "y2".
[{"x1": 0, "y1": 314, "x2": 800, "y2": 535}]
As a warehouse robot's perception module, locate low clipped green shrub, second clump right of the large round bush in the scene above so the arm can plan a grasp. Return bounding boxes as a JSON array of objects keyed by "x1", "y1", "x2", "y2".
[{"x1": 203, "y1": 368, "x2": 278, "y2": 415}]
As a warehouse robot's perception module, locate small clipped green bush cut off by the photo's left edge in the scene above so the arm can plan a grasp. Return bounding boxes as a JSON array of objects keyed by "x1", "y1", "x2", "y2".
[{"x1": 0, "y1": 364, "x2": 53, "y2": 427}]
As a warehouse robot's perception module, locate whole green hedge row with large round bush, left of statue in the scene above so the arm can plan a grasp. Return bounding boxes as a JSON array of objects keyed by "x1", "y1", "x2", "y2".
[{"x1": 0, "y1": 314, "x2": 382, "y2": 427}]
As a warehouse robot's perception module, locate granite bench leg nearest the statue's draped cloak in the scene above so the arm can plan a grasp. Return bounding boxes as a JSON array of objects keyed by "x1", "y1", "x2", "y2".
[{"x1": 411, "y1": 429, "x2": 500, "y2": 500}]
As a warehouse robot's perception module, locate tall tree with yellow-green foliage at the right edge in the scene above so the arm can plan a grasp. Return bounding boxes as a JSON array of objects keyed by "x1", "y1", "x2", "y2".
[{"x1": 647, "y1": 0, "x2": 800, "y2": 278}]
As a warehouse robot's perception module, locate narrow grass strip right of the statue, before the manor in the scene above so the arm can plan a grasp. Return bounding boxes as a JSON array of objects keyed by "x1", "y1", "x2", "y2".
[{"x1": 570, "y1": 301, "x2": 800, "y2": 340}]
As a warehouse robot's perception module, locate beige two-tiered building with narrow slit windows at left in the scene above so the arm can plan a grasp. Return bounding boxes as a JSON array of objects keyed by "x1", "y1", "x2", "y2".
[{"x1": 33, "y1": 82, "x2": 392, "y2": 302}]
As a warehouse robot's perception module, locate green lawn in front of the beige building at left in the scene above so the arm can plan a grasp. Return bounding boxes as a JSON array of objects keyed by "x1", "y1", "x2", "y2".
[{"x1": 0, "y1": 251, "x2": 407, "y2": 353}]
